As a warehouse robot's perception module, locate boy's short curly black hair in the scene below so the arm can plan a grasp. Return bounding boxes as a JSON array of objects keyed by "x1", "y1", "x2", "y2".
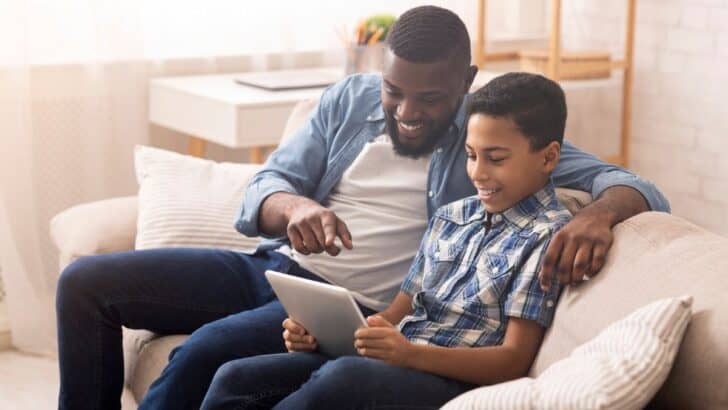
[{"x1": 468, "y1": 73, "x2": 566, "y2": 151}]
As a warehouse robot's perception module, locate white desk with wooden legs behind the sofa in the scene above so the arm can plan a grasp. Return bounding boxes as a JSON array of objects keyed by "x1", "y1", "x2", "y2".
[{"x1": 149, "y1": 68, "x2": 343, "y2": 163}]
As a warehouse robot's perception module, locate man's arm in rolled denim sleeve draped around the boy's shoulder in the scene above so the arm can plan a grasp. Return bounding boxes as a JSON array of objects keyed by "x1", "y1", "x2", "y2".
[{"x1": 539, "y1": 143, "x2": 670, "y2": 289}]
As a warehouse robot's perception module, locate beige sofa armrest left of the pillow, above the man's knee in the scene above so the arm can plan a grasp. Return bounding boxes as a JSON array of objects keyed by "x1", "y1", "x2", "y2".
[{"x1": 50, "y1": 196, "x2": 137, "y2": 270}]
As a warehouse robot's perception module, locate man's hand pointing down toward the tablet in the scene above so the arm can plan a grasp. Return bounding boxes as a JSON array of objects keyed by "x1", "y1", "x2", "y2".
[{"x1": 286, "y1": 200, "x2": 353, "y2": 256}]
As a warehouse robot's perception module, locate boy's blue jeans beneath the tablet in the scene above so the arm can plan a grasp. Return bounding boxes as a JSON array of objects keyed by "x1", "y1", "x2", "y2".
[{"x1": 202, "y1": 353, "x2": 475, "y2": 410}]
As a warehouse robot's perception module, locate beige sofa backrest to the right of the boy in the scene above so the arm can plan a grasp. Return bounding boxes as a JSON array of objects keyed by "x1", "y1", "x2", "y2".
[{"x1": 531, "y1": 212, "x2": 728, "y2": 409}]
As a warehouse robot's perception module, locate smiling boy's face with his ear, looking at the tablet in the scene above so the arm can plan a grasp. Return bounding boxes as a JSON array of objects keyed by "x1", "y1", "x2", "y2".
[{"x1": 465, "y1": 114, "x2": 559, "y2": 213}]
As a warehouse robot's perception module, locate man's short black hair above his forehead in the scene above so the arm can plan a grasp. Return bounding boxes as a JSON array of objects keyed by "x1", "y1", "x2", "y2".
[{"x1": 387, "y1": 6, "x2": 470, "y2": 67}]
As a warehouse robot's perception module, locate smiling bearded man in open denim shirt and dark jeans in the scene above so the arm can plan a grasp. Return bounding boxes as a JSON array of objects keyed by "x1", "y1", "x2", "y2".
[{"x1": 57, "y1": 6, "x2": 668, "y2": 409}]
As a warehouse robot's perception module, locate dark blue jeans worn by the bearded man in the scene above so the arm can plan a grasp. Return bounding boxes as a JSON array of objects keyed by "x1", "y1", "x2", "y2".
[{"x1": 56, "y1": 248, "x2": 366, "y2": 410}]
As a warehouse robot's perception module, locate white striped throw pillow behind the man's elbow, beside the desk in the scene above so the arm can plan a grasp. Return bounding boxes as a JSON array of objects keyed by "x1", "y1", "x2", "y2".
[{"x1": 134, "y1": 146, "x2": 260, "y2": 251}]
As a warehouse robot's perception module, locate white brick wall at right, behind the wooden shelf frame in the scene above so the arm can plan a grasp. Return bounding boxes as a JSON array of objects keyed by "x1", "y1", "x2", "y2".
[{"x1": 562, "y1": 0, "x2": 728, "y2": 235}]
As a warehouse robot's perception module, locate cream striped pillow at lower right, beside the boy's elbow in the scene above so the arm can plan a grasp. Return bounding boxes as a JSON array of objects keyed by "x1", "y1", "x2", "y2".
[{"x1": 443, "y1": 296, "x2": 692, "y2": 410}]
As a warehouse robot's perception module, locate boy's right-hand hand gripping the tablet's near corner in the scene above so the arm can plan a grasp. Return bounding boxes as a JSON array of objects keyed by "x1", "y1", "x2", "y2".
[{"x1": 354, "y1": 315, "x2": 413, "y2": 367}]
